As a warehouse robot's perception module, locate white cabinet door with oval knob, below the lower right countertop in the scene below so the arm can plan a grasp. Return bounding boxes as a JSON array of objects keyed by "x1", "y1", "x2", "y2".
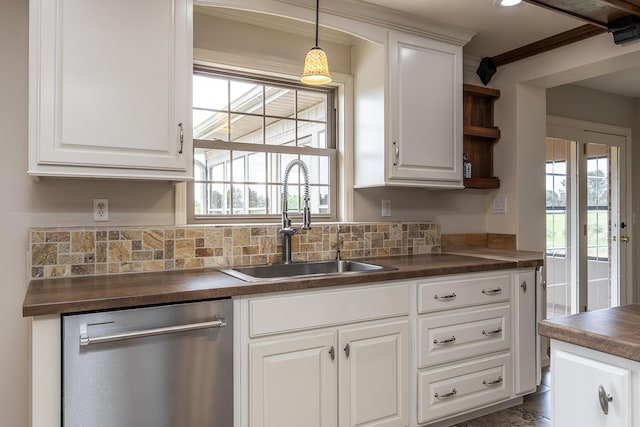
[{"x1": 551, "y1": 350, "x2": 637, "y2": 427}]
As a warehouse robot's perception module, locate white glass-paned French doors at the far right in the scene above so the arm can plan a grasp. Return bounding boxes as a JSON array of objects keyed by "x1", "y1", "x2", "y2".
[{"x1": 545, "y1": 123, "x2": 630, "y2": 318}]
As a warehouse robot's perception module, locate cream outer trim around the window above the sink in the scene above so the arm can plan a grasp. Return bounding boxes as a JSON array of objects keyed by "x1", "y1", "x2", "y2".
[{"x1": 175, "y1": 48, "x2": 354, "y2": 224}]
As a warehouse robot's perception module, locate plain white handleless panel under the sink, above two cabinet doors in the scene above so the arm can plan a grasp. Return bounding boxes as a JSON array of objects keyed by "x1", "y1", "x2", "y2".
[{"x1": 249, "y1": 282, "x2": 409, "y2": 337}]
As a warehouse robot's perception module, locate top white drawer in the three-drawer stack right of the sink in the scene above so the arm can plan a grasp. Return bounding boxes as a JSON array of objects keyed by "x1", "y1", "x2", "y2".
[{"x1": 418, "y1": 273, "x2": 512, "y2": 313}]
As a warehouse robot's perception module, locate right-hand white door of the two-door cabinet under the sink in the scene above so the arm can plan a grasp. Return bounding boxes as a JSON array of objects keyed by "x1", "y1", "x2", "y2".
[{"x1": 338, "y1": 320, "x2": 409, "y2": 427}]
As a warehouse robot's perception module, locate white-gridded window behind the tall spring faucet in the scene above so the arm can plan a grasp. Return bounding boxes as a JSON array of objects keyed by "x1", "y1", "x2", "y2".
[{"x1": 189, "y1": 68, "x2": 337, "y2": 222}]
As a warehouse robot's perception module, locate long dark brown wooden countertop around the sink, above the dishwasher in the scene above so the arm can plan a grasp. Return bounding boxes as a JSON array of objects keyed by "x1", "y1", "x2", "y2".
[{"x1": 22, "y1": 252, "x2": 542, "y2": 317}]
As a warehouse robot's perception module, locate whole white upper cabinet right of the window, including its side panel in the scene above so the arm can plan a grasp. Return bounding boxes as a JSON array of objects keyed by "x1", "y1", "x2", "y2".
[{"x1": 354, "y1": 31, "x2": 463, "y2": 188}]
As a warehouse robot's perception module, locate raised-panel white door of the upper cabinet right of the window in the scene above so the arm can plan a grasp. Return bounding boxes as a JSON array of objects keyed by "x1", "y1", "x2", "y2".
[{"x1": 387, "y1": 32, "x2": 463, "y2": 187}]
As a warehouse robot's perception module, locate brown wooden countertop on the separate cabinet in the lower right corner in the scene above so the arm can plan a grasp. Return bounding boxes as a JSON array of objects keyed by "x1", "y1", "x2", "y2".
[{"x1": 538, "y1": 304, "x2": 640, "y2": 362}]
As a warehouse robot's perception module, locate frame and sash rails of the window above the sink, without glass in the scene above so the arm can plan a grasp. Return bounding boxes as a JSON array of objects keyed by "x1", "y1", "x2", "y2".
[{"x1": 186, "y1": 64, "x2": 340, "y2": 224}]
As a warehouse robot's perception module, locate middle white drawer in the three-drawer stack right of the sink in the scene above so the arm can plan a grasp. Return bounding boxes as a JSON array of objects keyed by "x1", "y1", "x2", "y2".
[{"x1": 418, "y1": 305, "x2": 511, "y2": 368}]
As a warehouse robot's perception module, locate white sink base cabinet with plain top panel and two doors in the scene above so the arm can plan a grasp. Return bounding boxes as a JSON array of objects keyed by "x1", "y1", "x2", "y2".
[{"x1": 241, "y1": 282, "x2": 410, "y2": 427}]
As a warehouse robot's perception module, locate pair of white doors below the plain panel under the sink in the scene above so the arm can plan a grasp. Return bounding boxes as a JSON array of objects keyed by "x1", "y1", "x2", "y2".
[{"x1": 249, "y1": 319, "x2": 409, "y2": 427}]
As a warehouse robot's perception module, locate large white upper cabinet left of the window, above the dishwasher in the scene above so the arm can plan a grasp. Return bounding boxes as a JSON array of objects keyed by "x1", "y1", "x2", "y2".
[{"x1": 29, "y1": 0, "x2": 193, "y2": 180}]
